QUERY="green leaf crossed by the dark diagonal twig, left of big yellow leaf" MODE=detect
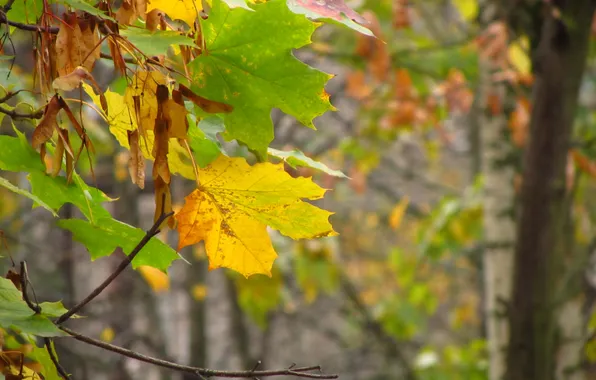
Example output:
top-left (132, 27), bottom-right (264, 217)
top-left (58, 218), bottom-right (179, 272)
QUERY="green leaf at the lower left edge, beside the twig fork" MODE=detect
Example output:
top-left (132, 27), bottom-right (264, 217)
top-left (0, 277), bottom-right (67, 337)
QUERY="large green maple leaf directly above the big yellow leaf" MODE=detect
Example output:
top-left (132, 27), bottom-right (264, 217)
top-left (190, 0), bottom-right (334, 157)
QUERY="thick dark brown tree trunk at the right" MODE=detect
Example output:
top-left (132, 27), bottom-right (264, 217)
top-left (507, 0), bottom-right (596, 380)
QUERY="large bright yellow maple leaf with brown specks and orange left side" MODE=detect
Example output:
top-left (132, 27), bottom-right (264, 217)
top-left (175, 156), bottom-right (336, 277)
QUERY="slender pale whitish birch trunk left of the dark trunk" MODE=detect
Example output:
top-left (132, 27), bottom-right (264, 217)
top-left (472, 1), bottom-right (516, 380)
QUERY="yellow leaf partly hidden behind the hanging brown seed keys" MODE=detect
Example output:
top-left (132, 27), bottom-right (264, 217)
top-left (83, 83), bottom-right (195, 180)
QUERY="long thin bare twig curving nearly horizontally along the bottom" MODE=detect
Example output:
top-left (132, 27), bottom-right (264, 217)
top-left (59, 326), bottom-right (338, 379)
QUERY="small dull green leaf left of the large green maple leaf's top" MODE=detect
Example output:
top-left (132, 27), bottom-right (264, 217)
top-left (120, 28), bottom-right (197, 56)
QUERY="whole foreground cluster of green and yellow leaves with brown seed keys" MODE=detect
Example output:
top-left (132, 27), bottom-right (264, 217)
top-left (0, 0), bottom-right (382, 379)
